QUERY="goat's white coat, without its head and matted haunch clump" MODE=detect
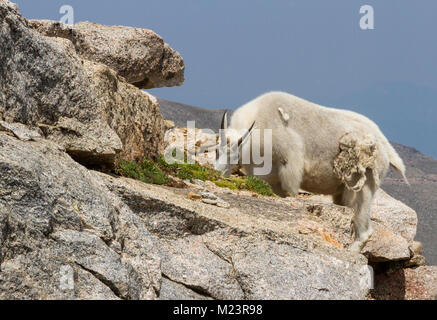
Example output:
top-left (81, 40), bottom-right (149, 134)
top-left (220, 92), bottom-right (406, 251)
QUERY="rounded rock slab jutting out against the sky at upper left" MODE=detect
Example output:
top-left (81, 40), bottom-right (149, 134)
top-left (29, 20), bottom-right (185, 89)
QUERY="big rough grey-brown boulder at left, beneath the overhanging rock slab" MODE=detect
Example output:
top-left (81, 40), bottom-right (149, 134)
top-left (0, 0), bottom-right (165, 167)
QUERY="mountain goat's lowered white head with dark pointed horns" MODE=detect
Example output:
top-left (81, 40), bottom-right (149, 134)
top-left (214, 112), bottom-right (255, 176)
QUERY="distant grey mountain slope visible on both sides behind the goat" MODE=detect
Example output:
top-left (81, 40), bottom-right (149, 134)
top-left (157, 98), bottom-right (437, 265)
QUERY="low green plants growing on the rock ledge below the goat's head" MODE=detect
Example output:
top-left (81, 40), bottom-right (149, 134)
top-left (116, 157), bottom-right (274, 196)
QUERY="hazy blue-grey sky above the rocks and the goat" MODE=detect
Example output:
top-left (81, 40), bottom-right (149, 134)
top-left (16, 0), bottom-right (437, 158)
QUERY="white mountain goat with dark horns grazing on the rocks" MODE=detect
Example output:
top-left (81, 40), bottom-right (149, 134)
top-left (214, 92), bottom-right (408, 251)
